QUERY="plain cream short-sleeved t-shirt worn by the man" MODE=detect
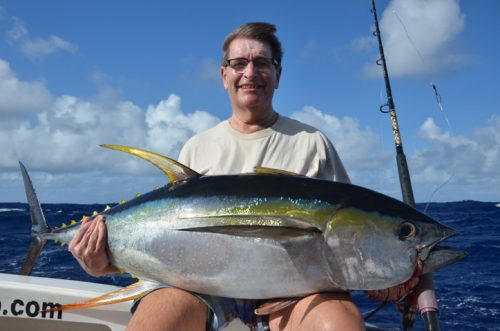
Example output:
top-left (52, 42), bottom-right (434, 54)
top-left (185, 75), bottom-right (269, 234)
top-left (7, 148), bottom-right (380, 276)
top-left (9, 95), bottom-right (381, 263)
top-left (179, 115), bottom-right (349, 183)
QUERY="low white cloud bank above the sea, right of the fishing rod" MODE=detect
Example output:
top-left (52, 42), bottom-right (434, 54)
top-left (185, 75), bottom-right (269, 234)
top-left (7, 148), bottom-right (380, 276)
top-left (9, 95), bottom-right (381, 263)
top-left (410, 116), bottom-right (500, 200)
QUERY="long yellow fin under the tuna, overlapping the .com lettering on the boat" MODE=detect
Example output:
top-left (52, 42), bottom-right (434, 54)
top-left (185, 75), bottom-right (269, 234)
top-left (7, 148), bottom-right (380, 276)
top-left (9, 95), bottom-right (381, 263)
top-left (45, 280), bottom-right (159, 312)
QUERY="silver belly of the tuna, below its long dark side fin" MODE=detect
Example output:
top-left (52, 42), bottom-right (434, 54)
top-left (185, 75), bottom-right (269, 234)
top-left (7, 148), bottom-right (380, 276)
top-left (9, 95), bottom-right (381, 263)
top-left (108, 224), bottom-right (335, 299)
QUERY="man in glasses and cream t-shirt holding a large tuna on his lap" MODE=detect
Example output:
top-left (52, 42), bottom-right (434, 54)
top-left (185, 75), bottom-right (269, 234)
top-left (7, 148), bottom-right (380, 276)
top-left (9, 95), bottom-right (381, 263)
top-left (69, 23), bottom-right (382, 331)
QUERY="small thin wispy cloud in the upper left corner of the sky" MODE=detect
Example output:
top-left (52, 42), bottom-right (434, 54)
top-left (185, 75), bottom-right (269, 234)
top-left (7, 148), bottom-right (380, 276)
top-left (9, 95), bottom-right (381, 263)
top-left (7, 18), bottom-right (78, 62)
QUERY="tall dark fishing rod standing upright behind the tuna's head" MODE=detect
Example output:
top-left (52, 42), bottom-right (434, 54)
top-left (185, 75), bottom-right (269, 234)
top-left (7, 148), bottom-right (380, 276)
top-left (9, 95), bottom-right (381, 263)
top-left (371, 0), bottom-right (440, 331)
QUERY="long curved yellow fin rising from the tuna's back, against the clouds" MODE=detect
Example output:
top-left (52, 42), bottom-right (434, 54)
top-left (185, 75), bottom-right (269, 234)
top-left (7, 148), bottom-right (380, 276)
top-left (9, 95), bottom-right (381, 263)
top-left (101, 144), bottom-right (200, 184)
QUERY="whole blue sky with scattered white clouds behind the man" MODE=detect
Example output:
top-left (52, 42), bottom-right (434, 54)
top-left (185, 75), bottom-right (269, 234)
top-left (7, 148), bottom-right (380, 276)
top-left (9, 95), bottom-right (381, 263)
top-left (0, 0), bottom-right (500, 203)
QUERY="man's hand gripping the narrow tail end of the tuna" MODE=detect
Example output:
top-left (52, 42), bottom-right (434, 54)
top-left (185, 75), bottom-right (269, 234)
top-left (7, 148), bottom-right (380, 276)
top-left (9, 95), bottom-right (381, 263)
top-left (68, 215), bottom-right (118, 277)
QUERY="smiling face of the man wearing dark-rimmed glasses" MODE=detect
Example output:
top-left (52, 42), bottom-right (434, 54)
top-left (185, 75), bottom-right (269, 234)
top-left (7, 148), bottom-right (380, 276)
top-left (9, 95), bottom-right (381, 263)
top-left (220, 38), bottom-right (281, 111)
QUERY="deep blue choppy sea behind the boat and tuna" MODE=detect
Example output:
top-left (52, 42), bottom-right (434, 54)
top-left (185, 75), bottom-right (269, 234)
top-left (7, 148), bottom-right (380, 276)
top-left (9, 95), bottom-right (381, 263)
top-left (0, 201), bottom-right (500, 331)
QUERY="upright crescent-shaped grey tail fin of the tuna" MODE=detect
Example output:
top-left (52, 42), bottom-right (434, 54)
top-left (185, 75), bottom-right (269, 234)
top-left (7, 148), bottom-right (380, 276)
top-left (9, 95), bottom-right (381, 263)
top-left (19, 162), bottom-right (50, 275)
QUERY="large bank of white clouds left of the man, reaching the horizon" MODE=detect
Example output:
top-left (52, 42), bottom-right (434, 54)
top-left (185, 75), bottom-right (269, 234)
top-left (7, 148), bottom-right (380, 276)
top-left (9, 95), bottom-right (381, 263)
top-left (0, 60), bottom-right (219, 203)
